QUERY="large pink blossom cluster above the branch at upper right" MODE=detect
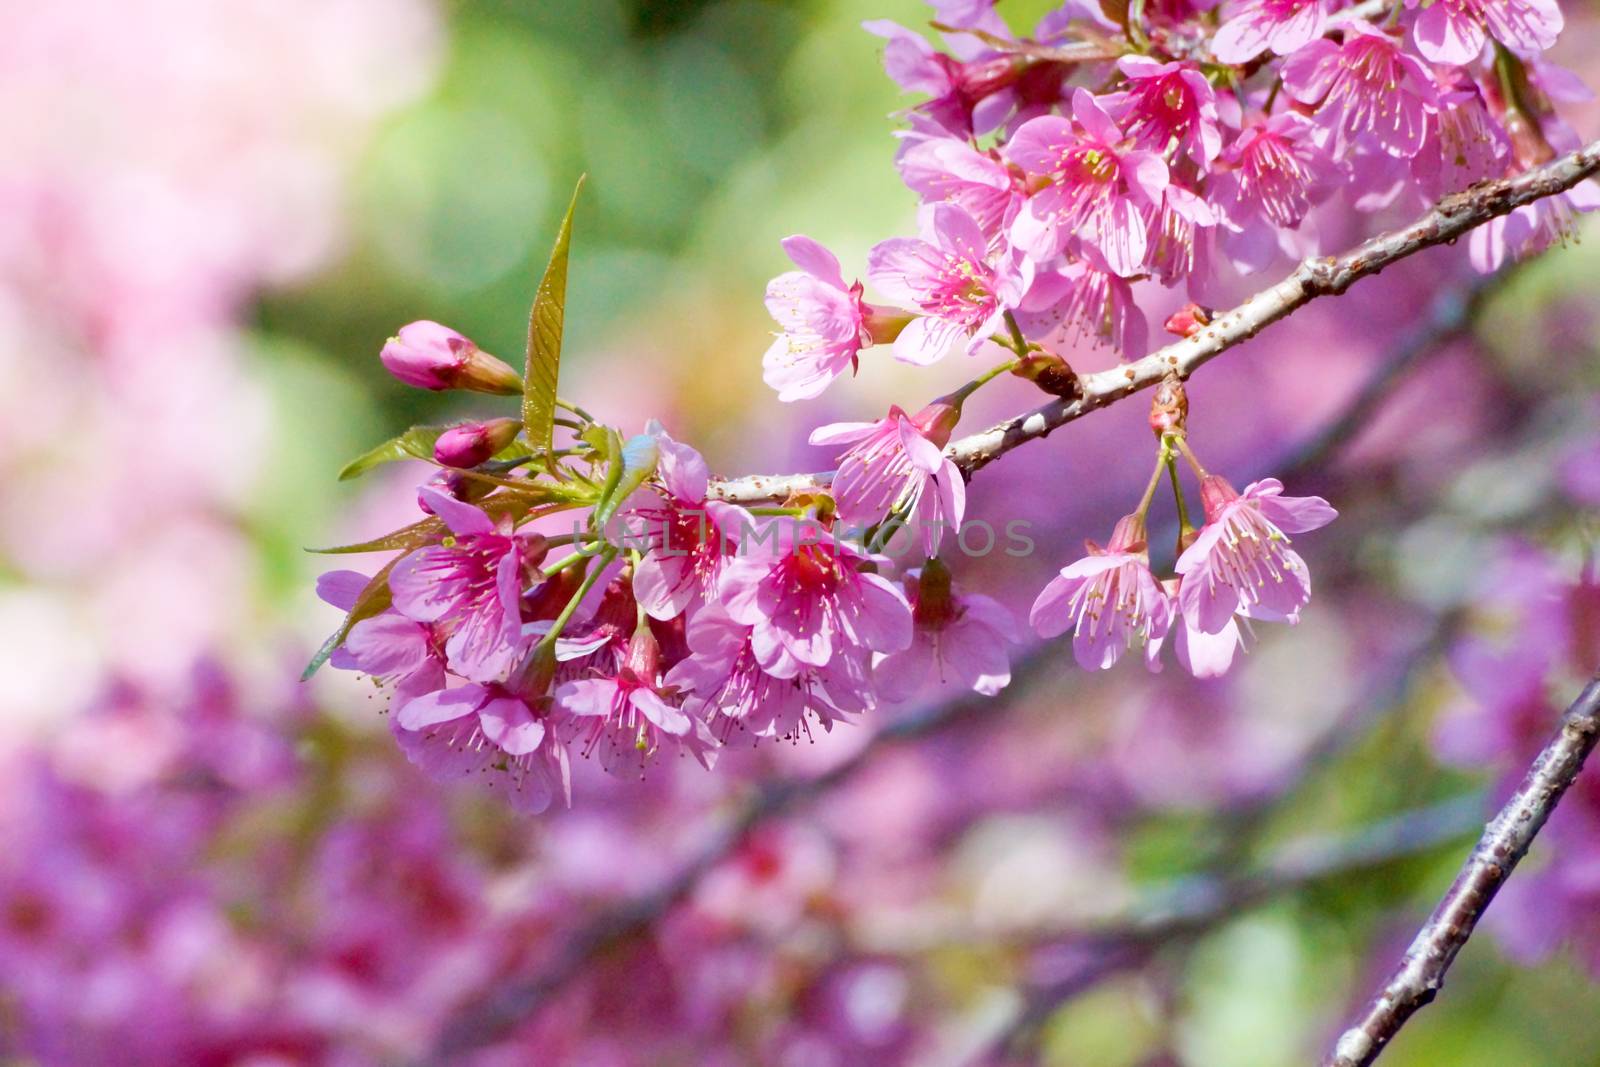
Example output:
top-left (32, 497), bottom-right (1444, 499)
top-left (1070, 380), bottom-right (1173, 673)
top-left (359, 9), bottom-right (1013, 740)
top-left (766, 0), bottom-right (1600, 400)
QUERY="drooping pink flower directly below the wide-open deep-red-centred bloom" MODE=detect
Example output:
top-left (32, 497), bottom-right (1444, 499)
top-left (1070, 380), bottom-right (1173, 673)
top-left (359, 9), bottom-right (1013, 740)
top-left (666, 601), bottom-right (872, 741)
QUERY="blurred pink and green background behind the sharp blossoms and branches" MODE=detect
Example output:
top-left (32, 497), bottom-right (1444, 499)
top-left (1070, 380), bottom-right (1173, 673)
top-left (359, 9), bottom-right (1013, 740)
top-left (0, 0), bottom-right (1600, 1067)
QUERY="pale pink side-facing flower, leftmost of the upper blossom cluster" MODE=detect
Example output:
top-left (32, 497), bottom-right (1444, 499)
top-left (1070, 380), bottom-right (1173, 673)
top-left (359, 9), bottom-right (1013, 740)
top-left (762, 234), bottom-right (872, 402)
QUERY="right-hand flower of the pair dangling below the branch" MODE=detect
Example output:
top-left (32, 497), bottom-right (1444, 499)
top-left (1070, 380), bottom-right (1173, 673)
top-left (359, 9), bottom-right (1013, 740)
top-left (1176, 475), bottom-right (1338, 633)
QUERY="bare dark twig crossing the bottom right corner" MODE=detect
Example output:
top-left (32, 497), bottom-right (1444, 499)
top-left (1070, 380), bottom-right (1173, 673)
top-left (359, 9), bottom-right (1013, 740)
top-left (1323, 675), bottom-right (1600, 1067)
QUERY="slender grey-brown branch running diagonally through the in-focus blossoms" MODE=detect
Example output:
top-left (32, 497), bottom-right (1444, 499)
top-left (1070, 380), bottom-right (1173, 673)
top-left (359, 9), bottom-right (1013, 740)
top-left (712, 141), bottom-right (1600, 504)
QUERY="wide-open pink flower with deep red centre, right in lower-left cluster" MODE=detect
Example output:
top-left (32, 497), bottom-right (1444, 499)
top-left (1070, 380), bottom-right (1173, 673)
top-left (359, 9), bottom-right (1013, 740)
top-left (717, 517), bottom-right (912, 672)
